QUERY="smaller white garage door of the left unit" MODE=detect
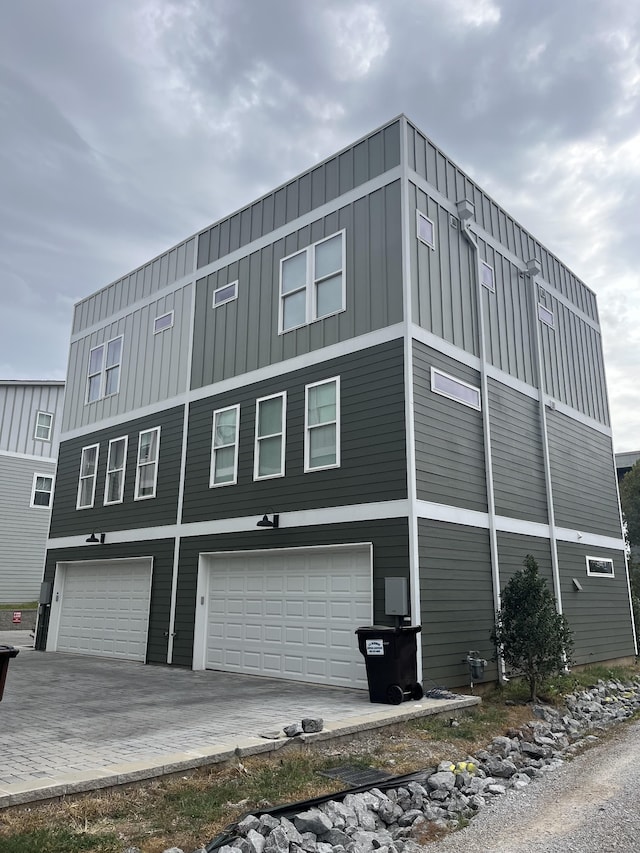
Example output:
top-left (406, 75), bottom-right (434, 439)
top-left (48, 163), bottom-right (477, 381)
top-left (51, 558), bottom-right (151, 661)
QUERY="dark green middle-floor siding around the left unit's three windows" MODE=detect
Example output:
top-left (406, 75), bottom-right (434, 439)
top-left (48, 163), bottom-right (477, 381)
top-left (50, 406), bottom-right (184, 537)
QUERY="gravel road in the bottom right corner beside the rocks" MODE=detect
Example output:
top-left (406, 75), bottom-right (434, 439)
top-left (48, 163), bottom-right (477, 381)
top-left (425, 722), bottom-right (640, 853)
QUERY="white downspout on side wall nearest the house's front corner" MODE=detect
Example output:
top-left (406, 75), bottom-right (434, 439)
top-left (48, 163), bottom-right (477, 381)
top-left (456, 198), bottom-right (509, 684)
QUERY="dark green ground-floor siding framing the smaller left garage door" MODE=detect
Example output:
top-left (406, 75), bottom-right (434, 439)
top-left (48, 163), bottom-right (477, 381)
top-left (37, 539), bottom-right (174, 663)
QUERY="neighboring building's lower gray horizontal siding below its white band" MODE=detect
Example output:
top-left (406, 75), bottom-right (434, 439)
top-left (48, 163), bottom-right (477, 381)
top-left (0, 453), bottom-right (56, 604)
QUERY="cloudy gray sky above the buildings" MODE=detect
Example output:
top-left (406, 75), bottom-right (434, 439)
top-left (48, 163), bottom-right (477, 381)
top-left (0, 0), bottom-right (640, 451)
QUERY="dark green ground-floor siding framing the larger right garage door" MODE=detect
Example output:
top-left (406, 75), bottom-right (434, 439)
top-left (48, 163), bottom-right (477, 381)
top-left (173, 518), bottom-right (409, 666)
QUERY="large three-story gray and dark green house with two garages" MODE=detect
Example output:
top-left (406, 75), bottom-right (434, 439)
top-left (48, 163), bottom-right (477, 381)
top-left (38, 116), bottom-right (636, 687)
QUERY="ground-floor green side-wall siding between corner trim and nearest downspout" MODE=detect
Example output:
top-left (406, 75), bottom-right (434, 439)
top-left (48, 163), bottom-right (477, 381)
top-left (418, 519), bottom-right (497, 687)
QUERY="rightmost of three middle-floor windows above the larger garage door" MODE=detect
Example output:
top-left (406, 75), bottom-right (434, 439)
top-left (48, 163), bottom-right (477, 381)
top-left (304, 377), bottom-right (340, 471)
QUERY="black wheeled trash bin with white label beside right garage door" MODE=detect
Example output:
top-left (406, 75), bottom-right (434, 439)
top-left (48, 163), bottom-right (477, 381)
top-left (356, 625), bottom-right (424, 705)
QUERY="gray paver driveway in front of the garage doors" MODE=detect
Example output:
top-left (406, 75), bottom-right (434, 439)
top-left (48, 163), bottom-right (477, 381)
top-left (0, 632), bottom-right (479, 808)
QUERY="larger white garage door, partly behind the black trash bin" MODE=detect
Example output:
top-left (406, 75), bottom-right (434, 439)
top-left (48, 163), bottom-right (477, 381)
top-left (201, 545), bottom-right (372, 688)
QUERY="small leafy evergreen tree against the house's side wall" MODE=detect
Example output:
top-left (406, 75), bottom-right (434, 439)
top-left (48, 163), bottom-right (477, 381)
top-left (491, 554), bottom-right (573, 702)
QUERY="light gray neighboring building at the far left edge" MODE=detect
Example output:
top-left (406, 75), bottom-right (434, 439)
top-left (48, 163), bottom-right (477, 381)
top-left (0, 379), bottom-right (64, 604)
